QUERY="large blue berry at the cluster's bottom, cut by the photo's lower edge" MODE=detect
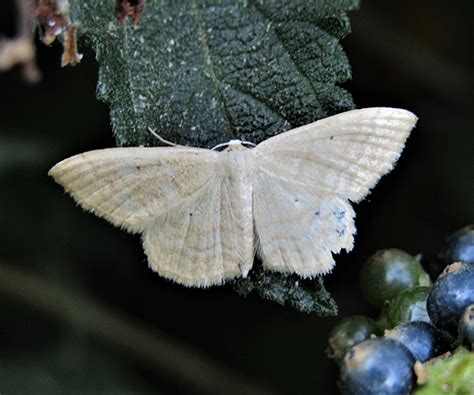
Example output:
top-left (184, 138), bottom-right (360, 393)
top-left (340, 338), bottom-right (415, 395)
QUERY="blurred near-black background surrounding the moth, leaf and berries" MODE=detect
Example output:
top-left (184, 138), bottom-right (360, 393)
top-left (0, 0), bottom-right (474, 394)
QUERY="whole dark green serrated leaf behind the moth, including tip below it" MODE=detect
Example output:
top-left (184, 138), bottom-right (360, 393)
top-left (70, 0), bottom-right (359, 315)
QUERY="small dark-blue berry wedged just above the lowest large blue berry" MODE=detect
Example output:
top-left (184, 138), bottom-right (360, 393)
top-left (385, 321), bottom-right (449, 362)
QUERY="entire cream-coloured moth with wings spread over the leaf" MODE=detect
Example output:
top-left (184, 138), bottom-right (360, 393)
top-left (49, 108), bottom-right (417, 287)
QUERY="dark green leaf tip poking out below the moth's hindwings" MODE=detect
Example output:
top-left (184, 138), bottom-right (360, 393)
top-left (232, 265), bottom-right (337, 317)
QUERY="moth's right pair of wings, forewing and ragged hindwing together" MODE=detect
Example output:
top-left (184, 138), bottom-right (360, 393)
top-left (254, 108), bottom-right (417, 276)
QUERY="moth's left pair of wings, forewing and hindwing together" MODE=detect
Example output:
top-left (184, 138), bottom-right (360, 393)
top-left (49, 147), bottom-right (254, 286)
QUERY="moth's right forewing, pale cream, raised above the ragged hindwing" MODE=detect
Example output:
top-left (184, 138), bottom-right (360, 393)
top-left (255, 107), bottom-right (417, 202)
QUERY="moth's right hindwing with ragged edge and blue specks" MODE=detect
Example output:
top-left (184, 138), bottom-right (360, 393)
top-left (254, 171), bottom-right (355, 277)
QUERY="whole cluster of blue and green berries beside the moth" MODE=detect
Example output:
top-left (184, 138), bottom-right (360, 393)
top-left (328, 226), bottom-right (474, 395)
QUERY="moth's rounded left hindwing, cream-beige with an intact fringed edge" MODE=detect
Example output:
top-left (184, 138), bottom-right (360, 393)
top-left (142, 177), bottom-right (254, 287)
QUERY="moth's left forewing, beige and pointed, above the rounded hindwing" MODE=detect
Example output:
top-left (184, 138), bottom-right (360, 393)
top-left (49, 147), bottom-right (217, 233)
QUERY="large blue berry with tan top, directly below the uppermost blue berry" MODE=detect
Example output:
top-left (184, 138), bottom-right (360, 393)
top-left (427, 262), bottom-right (474, 336)
